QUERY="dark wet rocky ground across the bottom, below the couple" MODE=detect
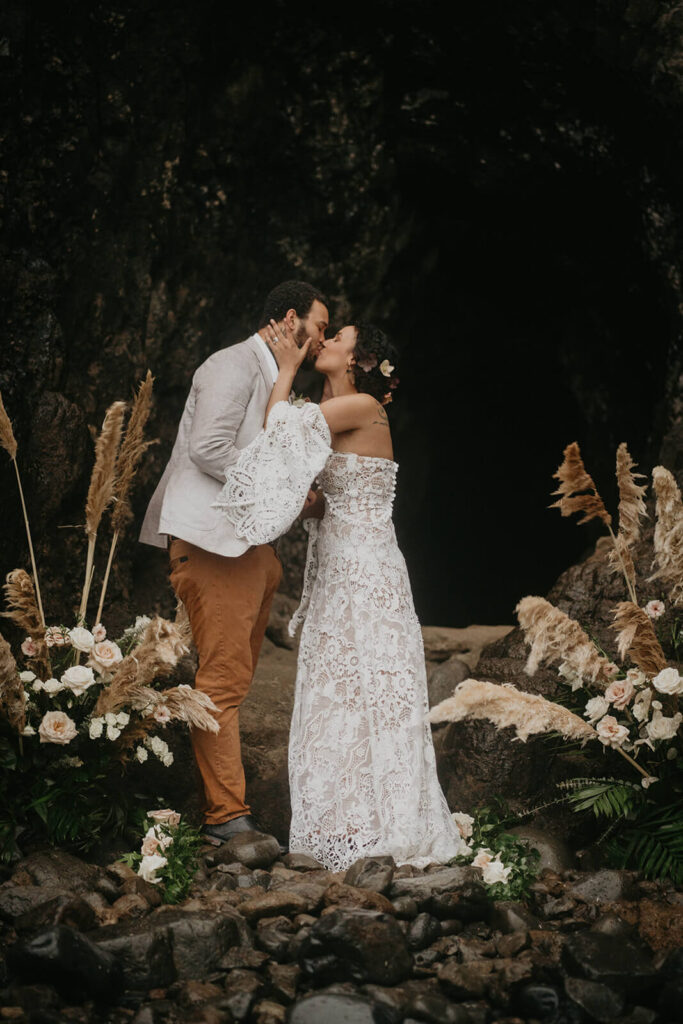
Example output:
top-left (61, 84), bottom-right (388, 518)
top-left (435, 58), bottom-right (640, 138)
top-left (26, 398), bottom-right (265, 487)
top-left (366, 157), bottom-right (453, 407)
top-left (0, 833), bottom-right (683, 1024)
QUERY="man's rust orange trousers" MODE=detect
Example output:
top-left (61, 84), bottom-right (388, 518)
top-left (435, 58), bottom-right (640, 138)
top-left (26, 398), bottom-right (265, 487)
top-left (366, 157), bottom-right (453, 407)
top-left (170, 540), bottom-right (282, 824)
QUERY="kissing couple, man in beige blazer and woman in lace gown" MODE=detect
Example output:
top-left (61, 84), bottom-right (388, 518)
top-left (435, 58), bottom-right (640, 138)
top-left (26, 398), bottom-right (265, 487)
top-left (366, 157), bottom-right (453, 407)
top-left (140, 281), bottom-right (466, 870)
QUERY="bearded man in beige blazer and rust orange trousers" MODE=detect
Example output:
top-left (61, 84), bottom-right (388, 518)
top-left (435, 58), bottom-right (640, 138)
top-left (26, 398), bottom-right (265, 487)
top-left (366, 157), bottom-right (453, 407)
top-left (140, 281), bottom-right (329, 846)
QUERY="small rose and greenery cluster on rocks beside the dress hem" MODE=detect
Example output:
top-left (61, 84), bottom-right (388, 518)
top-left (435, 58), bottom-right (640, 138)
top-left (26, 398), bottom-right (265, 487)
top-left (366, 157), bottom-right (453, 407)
top-left (453, 807), bottom-right (541, 900)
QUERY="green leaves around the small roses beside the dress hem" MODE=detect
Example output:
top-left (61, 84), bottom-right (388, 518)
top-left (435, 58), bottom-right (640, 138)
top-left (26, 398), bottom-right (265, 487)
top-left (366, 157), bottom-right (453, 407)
top-left (452, 800), bottom-right (541, 900)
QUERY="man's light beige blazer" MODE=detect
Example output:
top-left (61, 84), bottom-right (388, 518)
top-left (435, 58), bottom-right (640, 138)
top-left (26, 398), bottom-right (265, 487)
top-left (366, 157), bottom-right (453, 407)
top-left (140, 334), bottom-right (276, 556)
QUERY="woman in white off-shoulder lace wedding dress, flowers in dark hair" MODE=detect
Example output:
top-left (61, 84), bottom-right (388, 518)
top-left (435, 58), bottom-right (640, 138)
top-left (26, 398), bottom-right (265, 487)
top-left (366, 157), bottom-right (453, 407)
top-left (216, 321), bottom-right (466, 870)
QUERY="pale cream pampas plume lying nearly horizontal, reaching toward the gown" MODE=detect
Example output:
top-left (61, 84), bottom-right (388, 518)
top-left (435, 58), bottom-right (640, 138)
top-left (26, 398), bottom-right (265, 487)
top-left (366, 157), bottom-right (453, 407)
top-left (429, 679), bottom-right (597, 742)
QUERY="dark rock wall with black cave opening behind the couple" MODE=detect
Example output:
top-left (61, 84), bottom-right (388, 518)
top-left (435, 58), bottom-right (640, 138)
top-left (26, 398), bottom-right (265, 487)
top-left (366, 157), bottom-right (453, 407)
top-left (0, 0), bottom-right (683, 625)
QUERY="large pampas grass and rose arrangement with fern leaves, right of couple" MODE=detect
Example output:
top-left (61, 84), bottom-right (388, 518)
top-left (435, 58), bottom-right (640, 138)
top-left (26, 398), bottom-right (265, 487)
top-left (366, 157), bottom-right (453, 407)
top-left (430, 443), bottom-right (683, 882)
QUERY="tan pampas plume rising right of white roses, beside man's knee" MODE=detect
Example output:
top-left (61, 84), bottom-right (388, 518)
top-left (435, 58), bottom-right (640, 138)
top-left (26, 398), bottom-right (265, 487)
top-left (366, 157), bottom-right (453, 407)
top-left (94, 617), bottom-right (187, 715)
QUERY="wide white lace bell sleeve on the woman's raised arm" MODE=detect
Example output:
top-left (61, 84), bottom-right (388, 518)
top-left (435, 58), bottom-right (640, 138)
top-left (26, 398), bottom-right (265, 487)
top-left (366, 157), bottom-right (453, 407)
top-left (211, 401), bottom-right (332, 544)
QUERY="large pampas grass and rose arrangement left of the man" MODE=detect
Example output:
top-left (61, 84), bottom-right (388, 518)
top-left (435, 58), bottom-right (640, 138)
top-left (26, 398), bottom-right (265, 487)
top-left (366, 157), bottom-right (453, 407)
top-left (0, 374), bottom-right (218, 858)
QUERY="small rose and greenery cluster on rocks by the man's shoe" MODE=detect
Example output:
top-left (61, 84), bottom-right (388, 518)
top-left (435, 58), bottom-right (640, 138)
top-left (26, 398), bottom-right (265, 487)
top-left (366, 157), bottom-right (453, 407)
top-left (122, 807), bottom-right (202, 903)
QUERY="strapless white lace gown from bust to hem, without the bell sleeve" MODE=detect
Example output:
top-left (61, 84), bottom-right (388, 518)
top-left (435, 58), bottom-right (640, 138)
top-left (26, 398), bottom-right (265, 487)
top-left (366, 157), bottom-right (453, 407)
top-left (289, 453), bottom-right (465, 870)
